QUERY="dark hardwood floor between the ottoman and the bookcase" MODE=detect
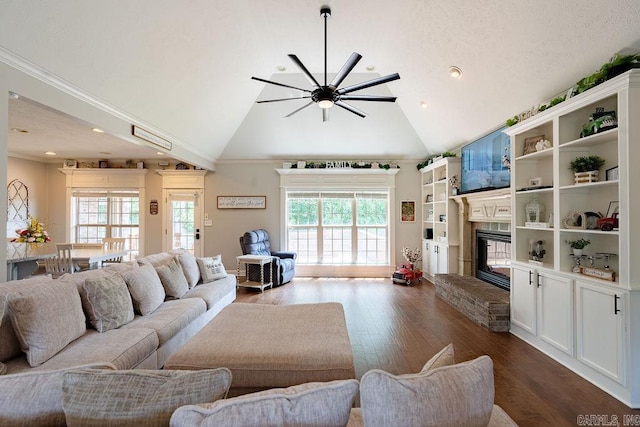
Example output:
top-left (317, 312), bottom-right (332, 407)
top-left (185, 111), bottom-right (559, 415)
top-left (237, 278), bottom-right (640, 426)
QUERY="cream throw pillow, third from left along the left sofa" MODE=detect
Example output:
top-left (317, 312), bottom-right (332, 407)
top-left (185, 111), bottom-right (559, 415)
top-left (122, 265), bottom-right (165, 316)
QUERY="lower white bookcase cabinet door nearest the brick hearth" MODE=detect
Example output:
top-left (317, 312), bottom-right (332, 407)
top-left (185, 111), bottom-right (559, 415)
top-left (511, 265), bottom-right (537, 335)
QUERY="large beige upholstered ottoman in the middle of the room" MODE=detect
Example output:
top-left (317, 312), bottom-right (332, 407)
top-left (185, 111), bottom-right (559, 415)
top-left (164, 303), bottom-right (355, 396)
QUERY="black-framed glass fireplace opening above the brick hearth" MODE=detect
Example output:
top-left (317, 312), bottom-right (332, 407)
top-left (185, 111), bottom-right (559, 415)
top-left (475, 230), bottom-right (511, 290)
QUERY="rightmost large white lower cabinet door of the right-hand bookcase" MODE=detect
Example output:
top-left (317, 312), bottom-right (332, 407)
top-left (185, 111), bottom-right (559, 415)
top-left (576, 281), bottom-right (626, 385)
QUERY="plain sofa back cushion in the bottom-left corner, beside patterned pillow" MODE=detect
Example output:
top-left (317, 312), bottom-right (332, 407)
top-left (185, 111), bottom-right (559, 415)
top-left (0, 363), bottom-right (116, 426)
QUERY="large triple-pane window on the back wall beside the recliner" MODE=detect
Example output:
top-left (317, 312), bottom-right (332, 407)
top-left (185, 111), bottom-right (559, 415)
top-left (287, 191), bottom-right (389, 265)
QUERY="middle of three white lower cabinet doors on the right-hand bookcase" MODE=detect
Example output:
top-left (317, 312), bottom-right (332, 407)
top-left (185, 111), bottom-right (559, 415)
top-left (537, 270), bottom-right (574, 356)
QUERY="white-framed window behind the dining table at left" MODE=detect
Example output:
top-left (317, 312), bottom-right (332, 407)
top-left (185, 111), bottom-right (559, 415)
top-left (71, 191), bottom-right (140, 258)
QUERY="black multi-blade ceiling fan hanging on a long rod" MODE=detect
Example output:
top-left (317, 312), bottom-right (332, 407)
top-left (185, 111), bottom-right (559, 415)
top-left (251, 6), bottom-right (400, 122)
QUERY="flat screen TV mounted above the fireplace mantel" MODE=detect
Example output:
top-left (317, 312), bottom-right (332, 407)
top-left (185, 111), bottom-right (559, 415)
top-left (460, 127), bottom-right (511, 193)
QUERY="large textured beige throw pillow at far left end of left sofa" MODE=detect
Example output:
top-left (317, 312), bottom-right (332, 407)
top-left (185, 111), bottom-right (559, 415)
top-left (7, 282), bottom-right (87, 367)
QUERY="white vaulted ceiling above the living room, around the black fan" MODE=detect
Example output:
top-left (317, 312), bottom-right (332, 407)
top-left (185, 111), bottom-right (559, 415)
top-left (0, 0), bottom-right (640, 166)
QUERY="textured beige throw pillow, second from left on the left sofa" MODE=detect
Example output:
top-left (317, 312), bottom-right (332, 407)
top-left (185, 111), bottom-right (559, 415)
top-left (80, 274), bottom-right (134, 332)
